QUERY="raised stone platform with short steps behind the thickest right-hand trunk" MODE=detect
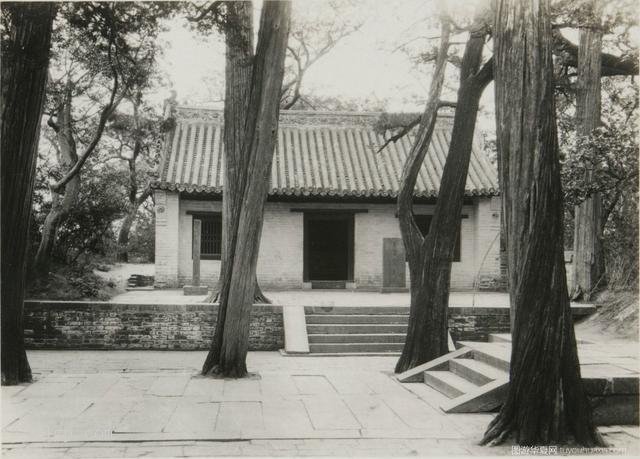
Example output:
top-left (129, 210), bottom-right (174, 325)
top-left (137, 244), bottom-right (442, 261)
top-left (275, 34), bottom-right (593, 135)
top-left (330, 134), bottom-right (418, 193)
top-left (397, 335), bottom-right (640, 425)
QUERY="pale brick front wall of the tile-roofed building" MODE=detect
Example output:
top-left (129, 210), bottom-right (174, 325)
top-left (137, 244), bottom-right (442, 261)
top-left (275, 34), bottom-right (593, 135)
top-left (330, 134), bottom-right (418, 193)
top-left (156, 192), bottom-right (500, 290)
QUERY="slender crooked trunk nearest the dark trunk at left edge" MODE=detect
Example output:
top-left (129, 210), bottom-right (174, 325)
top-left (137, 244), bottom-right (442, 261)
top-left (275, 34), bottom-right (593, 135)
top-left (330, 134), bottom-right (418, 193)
top-left (34, 82), bottom-right (80, 276)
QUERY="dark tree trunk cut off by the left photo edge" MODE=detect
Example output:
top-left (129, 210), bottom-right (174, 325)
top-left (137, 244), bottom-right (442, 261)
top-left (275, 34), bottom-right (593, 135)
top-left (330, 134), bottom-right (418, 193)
top-left (0, 3), bottom-right (56, 385)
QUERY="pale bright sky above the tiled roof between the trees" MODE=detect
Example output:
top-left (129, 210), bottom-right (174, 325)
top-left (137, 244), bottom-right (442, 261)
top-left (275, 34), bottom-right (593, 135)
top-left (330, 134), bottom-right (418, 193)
top-left (158, 0), bottom-right (492, 115)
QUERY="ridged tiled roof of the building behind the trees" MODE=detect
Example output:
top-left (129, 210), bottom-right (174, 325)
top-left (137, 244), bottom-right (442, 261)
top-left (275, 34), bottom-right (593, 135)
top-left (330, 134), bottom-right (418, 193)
top-left (153, 107), bottom-right (498, 198)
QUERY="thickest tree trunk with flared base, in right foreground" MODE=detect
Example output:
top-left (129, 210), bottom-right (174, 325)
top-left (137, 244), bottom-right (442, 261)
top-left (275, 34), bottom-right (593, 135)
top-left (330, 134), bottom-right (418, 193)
top-left (482, 0), bottom-right (602, 446)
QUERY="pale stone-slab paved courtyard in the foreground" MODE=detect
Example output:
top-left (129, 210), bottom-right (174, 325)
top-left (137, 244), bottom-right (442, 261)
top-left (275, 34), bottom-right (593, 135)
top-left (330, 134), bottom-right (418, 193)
top-left (2, 351), bottom-right (640, 458)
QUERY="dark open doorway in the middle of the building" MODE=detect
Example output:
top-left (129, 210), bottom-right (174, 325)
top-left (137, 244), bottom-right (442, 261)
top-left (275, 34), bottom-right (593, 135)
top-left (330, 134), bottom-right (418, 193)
top-left (304, 213), bottom-right (353, 282)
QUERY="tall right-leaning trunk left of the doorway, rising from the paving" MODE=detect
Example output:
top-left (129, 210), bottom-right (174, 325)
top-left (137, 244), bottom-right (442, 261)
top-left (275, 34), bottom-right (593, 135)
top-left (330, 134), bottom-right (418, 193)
top-left (203, 1), bottom-right (291, 377)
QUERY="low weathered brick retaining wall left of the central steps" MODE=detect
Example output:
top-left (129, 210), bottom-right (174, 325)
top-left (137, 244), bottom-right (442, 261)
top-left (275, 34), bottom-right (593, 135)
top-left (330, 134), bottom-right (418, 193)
top-left (24, 300), bottom-right (284, 351)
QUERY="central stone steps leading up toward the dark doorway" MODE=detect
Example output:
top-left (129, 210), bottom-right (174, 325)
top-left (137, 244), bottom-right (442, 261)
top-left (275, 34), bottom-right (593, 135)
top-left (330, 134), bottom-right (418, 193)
top-left (305, 306), bottom-right (409, 355)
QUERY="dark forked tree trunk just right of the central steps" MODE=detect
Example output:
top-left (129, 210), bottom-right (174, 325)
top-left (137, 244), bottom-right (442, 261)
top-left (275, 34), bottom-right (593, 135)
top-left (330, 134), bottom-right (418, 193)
top-left (395, 20), bottom-right (491, 373)
